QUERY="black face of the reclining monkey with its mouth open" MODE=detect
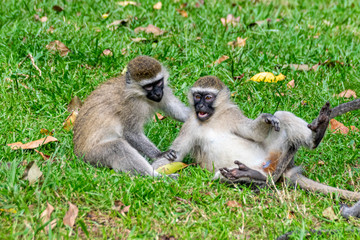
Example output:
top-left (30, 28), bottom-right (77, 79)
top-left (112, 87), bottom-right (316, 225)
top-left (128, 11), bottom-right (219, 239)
top-left (193, 92), bottom-right (216, 121)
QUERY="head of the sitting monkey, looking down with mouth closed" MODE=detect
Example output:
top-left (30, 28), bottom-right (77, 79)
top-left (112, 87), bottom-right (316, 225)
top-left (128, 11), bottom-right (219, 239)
top-left (126, 56), bottom-right (169, 102)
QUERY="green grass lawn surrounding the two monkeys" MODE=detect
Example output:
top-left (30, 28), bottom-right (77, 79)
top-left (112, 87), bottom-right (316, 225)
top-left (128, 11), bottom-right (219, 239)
top-left (0, 0), bottom-right (360, 239)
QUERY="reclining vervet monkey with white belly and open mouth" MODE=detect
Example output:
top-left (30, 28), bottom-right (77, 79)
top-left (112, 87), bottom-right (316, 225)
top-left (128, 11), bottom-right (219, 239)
top-left (162, 76), bottom-right (360, 218)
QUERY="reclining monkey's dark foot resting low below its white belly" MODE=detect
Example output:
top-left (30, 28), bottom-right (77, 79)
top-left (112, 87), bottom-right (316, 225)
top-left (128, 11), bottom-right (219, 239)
top-left (219, 161), bottom-right (266, 181)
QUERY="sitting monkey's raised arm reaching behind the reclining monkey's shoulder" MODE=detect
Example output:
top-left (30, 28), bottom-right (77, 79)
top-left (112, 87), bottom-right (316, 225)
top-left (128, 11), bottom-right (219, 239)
top-left (160, 87), bottom-right (190, 122)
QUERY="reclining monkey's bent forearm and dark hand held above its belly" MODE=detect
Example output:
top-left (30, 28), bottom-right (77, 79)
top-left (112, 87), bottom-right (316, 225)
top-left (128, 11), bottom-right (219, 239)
top-left (234, 113), bottom-right (280, 142)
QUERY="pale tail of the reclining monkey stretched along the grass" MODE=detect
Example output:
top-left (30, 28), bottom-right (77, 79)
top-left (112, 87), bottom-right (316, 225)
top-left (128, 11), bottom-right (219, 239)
top-left (285, 167), bottom-right (360, 200)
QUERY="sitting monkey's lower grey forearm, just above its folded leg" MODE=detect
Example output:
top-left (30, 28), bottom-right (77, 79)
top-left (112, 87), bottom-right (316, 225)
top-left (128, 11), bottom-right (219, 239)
top-left (124, 131), bottom-right (161, 159)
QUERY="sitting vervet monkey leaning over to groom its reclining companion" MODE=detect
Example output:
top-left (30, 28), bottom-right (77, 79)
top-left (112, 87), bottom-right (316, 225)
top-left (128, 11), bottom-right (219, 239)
top-left (74, 56), bottom-right (190, 176)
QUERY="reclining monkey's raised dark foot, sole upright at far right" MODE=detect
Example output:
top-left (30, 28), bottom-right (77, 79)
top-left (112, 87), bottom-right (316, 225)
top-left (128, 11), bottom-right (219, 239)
top-left (308, 101), bottom-right (331, 148)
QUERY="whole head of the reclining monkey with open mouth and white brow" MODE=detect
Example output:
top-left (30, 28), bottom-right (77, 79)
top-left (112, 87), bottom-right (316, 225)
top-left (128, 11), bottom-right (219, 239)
top-left (188, 76), bottom-right (230, 121)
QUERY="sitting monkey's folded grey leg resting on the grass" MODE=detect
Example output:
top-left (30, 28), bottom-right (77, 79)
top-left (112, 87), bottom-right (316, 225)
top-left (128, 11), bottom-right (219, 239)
top-left (85, 139), bottom-right (159, 176)
